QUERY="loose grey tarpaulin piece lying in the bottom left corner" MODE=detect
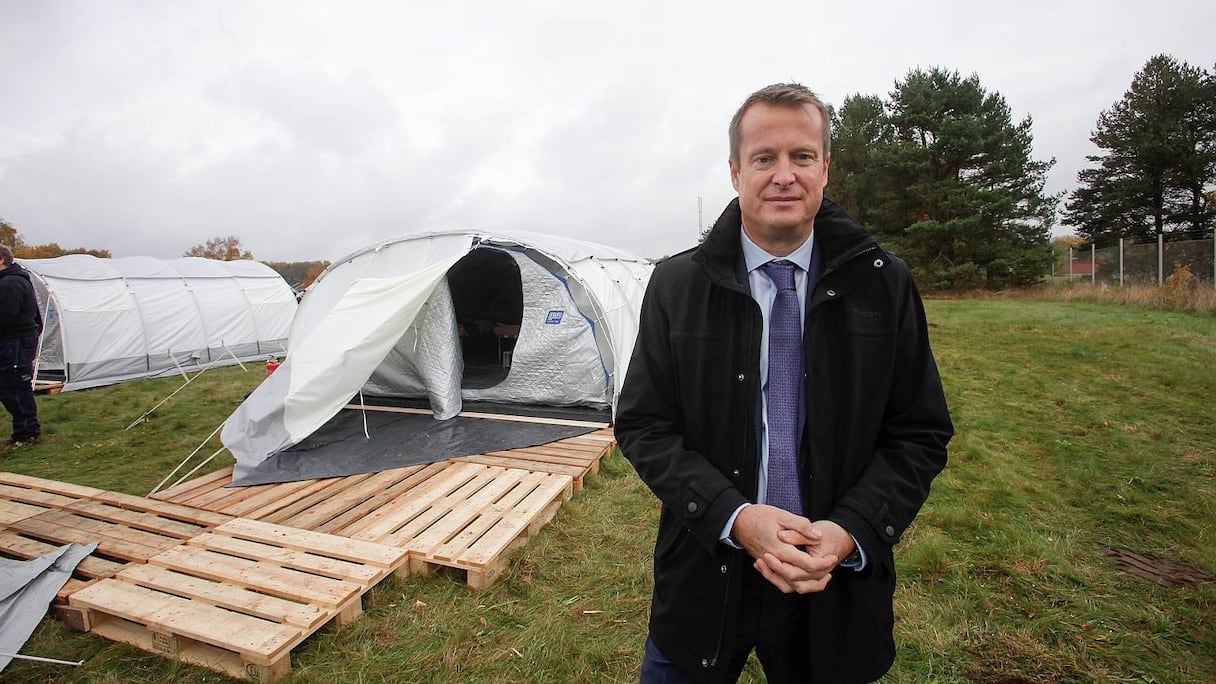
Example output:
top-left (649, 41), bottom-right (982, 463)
top-left (0, 542), bottom-right (97, 671)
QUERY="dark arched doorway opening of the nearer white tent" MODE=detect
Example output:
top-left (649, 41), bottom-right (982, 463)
top-left (447, 247), bottom-right (524, 389)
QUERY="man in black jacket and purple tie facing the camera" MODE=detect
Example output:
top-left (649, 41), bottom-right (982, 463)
top-left (615, 84), bottom-right (953, 684)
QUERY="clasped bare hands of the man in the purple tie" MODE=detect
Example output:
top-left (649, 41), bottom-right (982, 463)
top-left (731, 504), bottom-right (856, 594)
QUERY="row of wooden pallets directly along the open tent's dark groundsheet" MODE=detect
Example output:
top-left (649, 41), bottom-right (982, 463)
top-left (153, 428), bottom-right (615, 588)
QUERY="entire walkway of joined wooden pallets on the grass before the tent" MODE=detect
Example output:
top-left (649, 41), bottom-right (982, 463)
top-left (0, 430), bottom-right (615, 682)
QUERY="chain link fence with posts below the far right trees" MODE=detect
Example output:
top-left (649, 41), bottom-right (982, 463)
top-left (1052, 237), bottom-right (1216, 287)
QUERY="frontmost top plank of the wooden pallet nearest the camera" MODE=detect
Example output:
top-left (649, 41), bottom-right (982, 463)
top-left (69, 578), bottom-right (304, 663)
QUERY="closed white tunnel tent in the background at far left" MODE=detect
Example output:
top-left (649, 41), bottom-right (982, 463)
top-left (17, 254), bottom-right (297, 389)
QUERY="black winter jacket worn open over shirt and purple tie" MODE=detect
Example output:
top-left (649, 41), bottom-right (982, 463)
top-left (615, 200), bottom-right (953, 684)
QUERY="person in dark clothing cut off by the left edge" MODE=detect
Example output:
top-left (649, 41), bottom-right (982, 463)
top-left (0, 245), bottom-right (43, 445)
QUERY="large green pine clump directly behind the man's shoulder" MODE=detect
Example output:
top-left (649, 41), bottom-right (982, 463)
top-left (829, 68), bottom-right (1059, 288)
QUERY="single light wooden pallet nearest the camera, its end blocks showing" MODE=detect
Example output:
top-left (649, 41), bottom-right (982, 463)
top-left (68, 518), bottom-right (409, 682)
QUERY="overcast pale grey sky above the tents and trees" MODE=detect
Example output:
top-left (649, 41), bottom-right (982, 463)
top-left (0, 0), bottom-right (1216, 260)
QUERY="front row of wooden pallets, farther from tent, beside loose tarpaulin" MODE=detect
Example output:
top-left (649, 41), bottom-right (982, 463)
top-left (0, 473), bottom-right (409, 682)
